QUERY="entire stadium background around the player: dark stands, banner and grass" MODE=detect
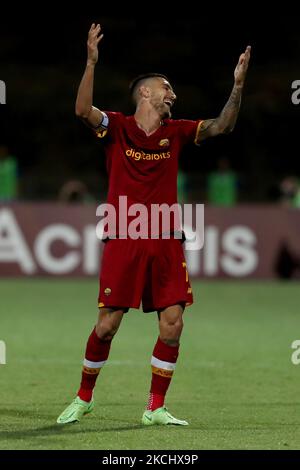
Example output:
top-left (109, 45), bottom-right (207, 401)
top-left (0, 13), bottom-right (300, 449)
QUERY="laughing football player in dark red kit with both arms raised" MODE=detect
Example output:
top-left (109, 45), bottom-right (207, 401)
top-left (57, 24), bottom-right (250, 425)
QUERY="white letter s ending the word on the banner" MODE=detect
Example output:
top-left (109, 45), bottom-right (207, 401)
top-left (220, 225), bottom-right (258, 277)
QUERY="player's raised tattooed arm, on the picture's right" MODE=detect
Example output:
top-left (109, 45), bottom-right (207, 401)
top-left (196, 46), bottom-right (251, 144)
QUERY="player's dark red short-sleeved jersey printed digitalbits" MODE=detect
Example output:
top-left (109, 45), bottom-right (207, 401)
top-left (96, 112), bottom-right (201, 237)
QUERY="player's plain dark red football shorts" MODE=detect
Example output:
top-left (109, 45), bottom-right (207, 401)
top-left (98, 238), bottom-right (193, 312)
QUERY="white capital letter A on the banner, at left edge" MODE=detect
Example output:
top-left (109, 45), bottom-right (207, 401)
top-left (0, 208), bottom-right (36, 274)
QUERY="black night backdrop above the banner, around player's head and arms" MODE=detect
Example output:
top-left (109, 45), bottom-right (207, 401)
top-left (0, 13), bottom-right (300, 202)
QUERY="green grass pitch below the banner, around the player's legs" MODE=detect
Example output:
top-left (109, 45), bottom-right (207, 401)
top-left (0, 279), bottom-right (300, 450)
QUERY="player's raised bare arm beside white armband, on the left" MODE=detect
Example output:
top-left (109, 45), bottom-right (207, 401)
top-left (75, 23), bottom-right (103, 127)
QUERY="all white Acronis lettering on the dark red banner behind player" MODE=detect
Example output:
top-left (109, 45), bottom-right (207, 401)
top-left (0, 206), bottom-right (258, 278)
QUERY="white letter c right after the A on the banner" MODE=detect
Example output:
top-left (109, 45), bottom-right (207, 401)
top-left (34, 224), bottom-right (81, 274)
